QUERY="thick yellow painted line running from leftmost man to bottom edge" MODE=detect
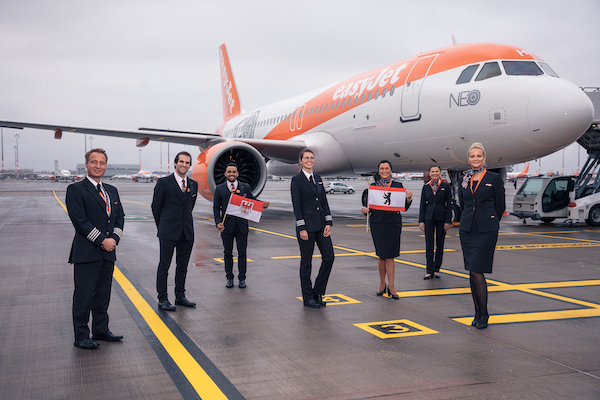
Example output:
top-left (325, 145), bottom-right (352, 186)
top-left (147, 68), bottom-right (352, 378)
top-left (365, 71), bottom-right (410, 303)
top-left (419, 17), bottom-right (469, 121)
top-left (113, 265), bottom-right (227, 399)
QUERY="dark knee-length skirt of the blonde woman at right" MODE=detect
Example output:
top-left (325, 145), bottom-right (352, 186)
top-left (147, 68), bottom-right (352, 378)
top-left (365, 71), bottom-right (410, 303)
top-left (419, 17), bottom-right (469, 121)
top-left (460, 223), bottom-right (498, 274)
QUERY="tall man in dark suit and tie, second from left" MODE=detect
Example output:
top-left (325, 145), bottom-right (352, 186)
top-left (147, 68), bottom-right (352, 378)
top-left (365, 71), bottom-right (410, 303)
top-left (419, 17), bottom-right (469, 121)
top-left (152, 151), bottom-right (198, 311)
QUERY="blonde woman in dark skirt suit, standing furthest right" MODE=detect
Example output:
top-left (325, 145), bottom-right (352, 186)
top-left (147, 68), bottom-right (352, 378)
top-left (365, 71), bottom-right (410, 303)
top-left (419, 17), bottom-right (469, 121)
top-left (459, 143), bottom-right (505, 329)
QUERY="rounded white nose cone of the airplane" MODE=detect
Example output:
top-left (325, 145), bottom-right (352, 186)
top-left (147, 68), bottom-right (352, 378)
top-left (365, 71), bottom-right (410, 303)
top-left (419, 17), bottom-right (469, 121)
top-left (528, 78), bottom-right (594, 147)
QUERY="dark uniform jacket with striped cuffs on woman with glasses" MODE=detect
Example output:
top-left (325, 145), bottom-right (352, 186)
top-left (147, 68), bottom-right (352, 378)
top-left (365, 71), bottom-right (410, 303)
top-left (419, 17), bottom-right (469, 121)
top-left (290, 171), bottom-right (333, 233)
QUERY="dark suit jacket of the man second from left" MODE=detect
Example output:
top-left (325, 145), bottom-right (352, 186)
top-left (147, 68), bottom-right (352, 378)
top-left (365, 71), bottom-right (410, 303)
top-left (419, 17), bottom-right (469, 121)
top-left (152, 173), bottom-right (198, 242)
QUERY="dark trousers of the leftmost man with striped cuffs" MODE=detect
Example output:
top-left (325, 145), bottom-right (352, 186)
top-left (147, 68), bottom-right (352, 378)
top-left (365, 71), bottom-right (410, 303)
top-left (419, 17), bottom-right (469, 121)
top-left (73, 260), bottom-right (115, 341)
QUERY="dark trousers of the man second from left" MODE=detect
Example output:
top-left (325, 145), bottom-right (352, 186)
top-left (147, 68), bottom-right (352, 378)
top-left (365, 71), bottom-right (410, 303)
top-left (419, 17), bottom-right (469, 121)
top-left (156, 233), bottom-right (194, 302)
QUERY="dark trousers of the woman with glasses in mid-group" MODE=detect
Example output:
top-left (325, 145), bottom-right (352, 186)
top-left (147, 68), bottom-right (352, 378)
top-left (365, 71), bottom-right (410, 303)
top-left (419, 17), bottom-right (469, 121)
top-left (297, 230), bottom-right (334, 300)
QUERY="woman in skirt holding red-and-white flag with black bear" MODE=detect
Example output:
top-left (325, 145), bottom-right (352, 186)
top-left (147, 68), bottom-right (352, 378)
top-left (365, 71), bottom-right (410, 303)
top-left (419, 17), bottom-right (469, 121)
top-left (361, 160), bottom-right (412, 300)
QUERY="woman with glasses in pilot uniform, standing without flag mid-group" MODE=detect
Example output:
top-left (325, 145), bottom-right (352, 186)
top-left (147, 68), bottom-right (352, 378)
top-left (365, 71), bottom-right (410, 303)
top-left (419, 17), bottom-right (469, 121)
top-left (291, 149), bottom-right (334, 308)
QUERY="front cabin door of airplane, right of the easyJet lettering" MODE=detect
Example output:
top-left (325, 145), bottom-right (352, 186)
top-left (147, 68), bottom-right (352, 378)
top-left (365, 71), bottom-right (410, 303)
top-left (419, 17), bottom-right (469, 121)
top-left (400, 54), bottom-right (439, 122)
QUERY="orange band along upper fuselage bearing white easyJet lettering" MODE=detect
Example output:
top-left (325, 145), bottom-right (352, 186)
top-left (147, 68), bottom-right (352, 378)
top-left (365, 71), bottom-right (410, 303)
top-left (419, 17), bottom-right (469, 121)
top-left (262, 43), bottom-right (541, 140)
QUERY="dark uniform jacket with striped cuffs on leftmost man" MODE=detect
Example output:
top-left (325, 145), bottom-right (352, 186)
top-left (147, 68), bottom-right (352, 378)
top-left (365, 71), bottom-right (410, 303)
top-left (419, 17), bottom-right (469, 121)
top-left (66, 178), bottom-right (125, 263)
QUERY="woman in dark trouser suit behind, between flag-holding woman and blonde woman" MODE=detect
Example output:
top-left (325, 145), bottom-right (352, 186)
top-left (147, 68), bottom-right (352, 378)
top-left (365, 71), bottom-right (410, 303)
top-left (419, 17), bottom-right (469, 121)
top-left (419, 165), bottom-right (452, 279)
